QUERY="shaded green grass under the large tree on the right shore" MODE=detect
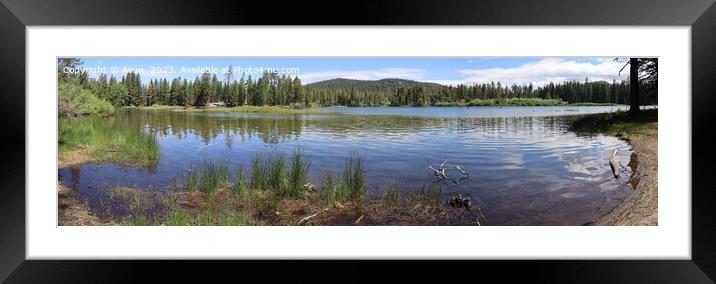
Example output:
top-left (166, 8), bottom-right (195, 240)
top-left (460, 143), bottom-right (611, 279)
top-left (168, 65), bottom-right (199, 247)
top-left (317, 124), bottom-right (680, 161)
top-left (570, 109), bottom-right (659, 138)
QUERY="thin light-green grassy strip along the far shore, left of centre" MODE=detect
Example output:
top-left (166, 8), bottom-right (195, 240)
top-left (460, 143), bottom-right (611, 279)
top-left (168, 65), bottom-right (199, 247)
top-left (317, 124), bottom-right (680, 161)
top-left (131, 105), bottom-right (334, 114)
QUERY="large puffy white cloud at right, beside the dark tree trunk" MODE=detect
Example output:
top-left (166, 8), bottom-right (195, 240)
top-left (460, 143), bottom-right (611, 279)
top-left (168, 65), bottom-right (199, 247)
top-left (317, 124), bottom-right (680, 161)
top-left (450, 58), bottom-right (628, 86)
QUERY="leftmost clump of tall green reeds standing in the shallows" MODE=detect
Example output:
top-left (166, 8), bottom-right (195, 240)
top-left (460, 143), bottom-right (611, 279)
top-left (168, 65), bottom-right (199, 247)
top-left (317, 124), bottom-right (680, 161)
top-left (184, 159), bottom-right (229, 196)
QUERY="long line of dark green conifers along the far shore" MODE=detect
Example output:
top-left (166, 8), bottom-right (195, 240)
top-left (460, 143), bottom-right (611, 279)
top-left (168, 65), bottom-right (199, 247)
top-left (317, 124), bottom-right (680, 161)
top-left (58, 58), bottom-right (656, 115)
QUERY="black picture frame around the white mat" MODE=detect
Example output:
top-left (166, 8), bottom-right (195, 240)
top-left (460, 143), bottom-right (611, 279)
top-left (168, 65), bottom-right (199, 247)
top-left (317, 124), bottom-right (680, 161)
top-left (0, 0), bottom-right (716, 283)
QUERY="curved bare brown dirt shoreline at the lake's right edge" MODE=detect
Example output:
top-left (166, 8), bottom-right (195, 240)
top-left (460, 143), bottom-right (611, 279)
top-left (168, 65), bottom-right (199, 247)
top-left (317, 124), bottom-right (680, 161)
top-left (590, 123), bottom-right (659, 226)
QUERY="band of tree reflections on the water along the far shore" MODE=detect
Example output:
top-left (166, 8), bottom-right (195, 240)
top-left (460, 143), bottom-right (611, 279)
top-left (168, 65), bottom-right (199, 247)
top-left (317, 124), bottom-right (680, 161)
top-left (115, 110), bottom-right (567, 145)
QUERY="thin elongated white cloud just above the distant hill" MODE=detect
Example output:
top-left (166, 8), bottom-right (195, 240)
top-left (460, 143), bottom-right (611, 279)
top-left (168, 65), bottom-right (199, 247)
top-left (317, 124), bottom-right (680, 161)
top-left (298, 68), bottom-right (428, 83)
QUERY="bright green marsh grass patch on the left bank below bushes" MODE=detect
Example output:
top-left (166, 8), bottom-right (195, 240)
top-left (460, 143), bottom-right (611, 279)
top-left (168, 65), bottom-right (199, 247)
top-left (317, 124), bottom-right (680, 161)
top-left (57, 117), bottom-right (159, 167)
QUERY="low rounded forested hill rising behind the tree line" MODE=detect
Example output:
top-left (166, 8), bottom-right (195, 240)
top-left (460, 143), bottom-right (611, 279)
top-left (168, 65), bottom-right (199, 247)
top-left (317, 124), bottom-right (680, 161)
top-left (306, 78), bottom-right (444, 93)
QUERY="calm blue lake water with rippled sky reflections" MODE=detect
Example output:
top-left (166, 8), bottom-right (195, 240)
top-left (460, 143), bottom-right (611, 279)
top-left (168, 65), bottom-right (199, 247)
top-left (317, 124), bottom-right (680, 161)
top-left (59, 107), bottom-right (631, 225)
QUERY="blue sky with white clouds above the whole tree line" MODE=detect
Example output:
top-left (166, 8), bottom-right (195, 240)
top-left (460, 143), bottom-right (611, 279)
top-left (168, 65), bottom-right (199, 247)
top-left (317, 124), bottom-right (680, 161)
top-left (75, 57), bottom-right (628, 86)
